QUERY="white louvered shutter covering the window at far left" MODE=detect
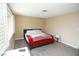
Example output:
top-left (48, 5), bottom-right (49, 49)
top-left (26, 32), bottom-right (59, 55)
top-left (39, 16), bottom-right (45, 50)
top-left (0, 3), bottom-right (9, 55)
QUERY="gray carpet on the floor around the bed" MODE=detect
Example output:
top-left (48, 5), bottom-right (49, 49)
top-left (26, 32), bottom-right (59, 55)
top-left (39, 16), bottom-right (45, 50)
top-left (15, 40), bottom-right (79, 56)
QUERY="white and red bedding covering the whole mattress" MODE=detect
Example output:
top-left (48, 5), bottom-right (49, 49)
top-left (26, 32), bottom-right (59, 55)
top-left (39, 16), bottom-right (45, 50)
top-left (25, 30), bottom-right (54, 49)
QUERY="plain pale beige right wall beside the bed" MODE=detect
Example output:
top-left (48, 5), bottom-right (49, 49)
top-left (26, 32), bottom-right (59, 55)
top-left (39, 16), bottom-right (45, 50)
top-left (45, 12), bottom-right (79, 48)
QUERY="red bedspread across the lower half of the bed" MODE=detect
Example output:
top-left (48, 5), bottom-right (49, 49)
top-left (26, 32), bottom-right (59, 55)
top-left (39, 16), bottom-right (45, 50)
top-left (27, 34), bottom-right (54, 46)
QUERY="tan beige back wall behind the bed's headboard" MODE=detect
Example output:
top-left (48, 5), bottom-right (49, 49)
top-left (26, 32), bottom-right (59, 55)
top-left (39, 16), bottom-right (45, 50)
top-left (15, 16), bottom-right (45, 38)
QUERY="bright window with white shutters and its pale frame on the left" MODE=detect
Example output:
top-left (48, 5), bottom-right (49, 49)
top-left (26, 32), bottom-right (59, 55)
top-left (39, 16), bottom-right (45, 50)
top-left (0, 3), bottom-right (14, 55)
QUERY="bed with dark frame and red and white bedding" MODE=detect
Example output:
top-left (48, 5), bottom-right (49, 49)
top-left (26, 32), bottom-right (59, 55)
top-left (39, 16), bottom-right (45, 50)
top-left (24, 29), bottom-right (54, 50)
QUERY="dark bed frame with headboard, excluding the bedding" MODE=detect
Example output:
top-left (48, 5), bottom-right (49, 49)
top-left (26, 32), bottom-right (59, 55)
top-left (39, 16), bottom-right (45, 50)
top-left (23, 29), bottom-right (53, 50)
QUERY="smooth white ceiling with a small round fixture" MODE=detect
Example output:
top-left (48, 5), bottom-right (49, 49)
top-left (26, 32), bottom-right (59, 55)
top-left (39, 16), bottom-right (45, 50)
top-left (9, 3), bottom-right (79, 18)
